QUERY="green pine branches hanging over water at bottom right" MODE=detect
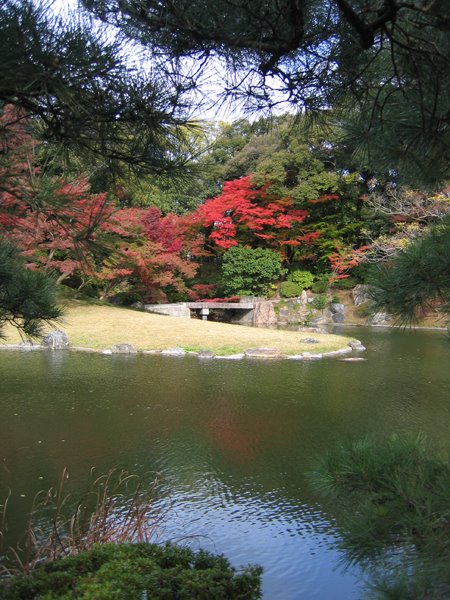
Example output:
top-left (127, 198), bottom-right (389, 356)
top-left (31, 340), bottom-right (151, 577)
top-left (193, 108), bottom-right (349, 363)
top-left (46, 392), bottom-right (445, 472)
top-left (313, 435), bottom-right (450, 600)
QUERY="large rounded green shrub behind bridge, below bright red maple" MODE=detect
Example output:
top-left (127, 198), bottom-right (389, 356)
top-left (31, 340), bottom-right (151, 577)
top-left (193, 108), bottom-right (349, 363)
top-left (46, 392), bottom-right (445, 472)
top-left (222, 246), bottom-right (283, 296)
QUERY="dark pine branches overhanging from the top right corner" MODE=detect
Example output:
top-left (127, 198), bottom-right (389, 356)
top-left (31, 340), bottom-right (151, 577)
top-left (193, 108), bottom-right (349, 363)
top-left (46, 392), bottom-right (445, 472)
top-left (82, 0), bottom-right (450, 182)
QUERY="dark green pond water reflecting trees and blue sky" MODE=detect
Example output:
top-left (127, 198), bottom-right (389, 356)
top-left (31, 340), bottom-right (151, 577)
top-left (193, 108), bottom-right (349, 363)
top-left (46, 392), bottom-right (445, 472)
top-left (0, 329), bottom-right (450, 600)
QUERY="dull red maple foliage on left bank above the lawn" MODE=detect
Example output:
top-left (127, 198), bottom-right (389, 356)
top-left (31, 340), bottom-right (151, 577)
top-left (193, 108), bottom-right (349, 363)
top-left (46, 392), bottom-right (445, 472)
top-left (0, 107), bottom-right (198, 299)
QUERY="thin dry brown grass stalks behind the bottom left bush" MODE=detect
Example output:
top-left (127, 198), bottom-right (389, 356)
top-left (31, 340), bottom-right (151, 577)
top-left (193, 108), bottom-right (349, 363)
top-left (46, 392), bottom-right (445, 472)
top-left (0, 469), bottom-right (161, 577)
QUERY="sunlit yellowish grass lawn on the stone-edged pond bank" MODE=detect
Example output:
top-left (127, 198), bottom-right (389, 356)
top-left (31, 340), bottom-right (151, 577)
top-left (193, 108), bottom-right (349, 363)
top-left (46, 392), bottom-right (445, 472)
top-left (4, 300), bottom-right (356, 354)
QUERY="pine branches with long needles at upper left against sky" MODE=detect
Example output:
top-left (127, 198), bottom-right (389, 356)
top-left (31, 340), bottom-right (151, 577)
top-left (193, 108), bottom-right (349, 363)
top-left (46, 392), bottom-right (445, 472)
top-left (0, 0), bottom-right (196, 180)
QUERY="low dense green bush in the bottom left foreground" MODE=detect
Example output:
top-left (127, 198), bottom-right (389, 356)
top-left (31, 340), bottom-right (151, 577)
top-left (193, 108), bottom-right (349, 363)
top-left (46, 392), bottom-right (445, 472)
top-left (0, 543), bottom-right (262, 600)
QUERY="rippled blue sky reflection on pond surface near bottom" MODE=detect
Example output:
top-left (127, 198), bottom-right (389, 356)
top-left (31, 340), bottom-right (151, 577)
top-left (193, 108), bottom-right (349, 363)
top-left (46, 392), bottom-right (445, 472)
top-left (151, 473), bottom-right (357, 600)
